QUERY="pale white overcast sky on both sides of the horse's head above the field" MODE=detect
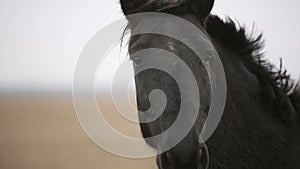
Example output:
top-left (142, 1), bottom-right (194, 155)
top-left (0, 0), bottom-right (300, 90)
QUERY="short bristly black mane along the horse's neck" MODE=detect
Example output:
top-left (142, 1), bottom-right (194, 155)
top-left (205, 15), bottom-right (300, 124)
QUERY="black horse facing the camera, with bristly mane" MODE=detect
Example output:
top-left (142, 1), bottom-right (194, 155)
top-left (121, 0), bottom-right (300, 169)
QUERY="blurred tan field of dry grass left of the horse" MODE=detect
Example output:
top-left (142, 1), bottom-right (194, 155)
top-left (0, 94), bottom-right (156, 169)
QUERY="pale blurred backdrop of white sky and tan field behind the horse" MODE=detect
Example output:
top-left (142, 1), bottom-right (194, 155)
top-left (0, 0), bottom-right (300, 169)
